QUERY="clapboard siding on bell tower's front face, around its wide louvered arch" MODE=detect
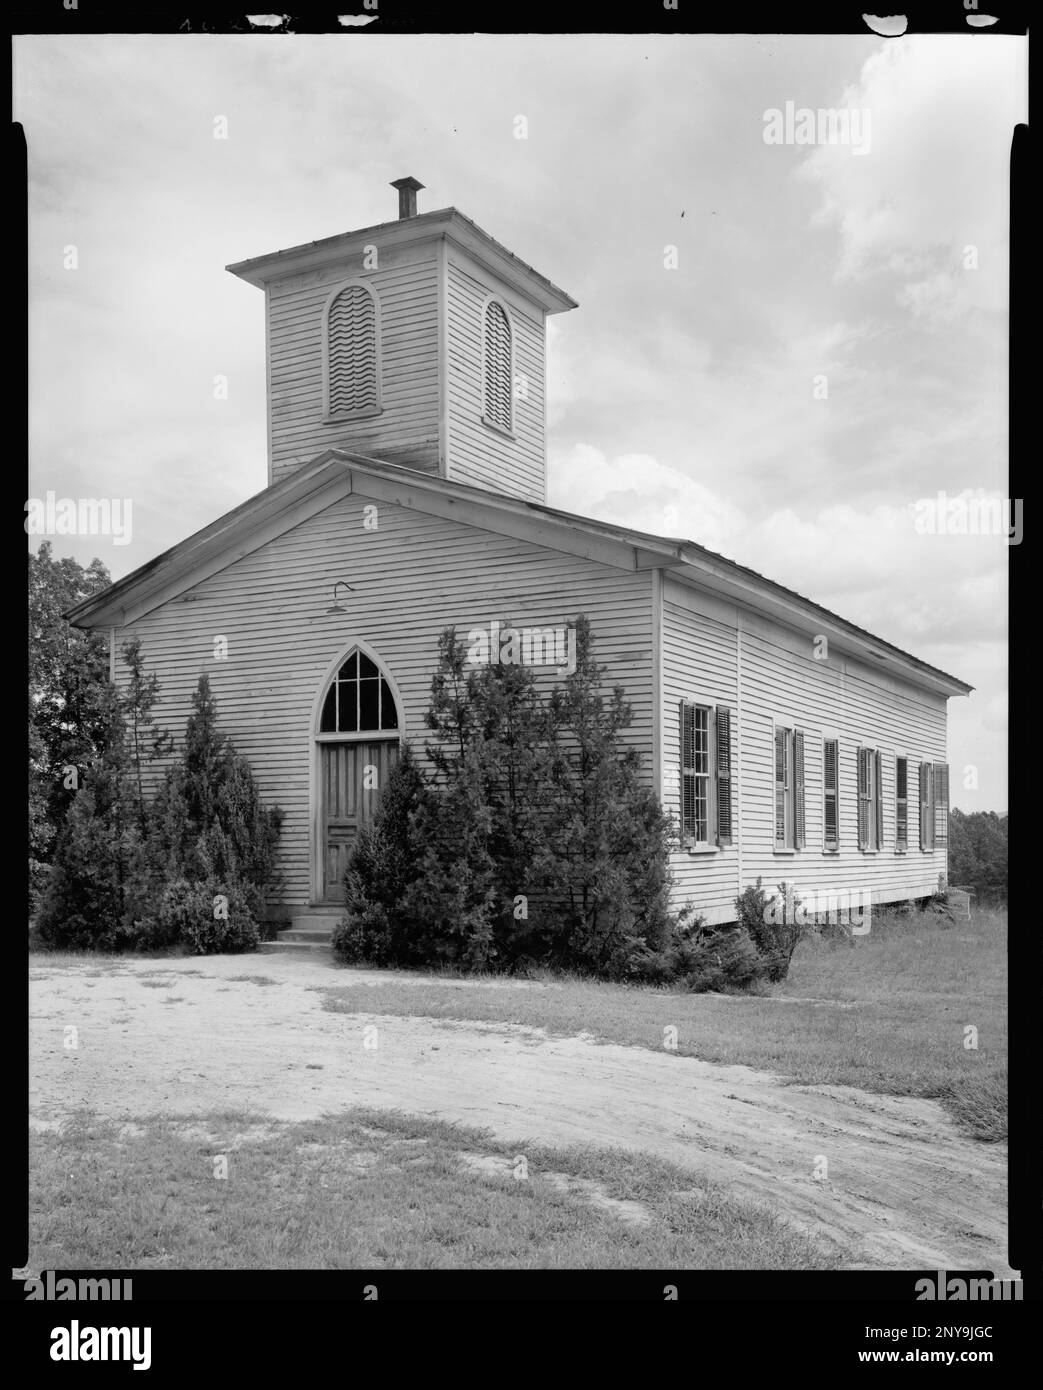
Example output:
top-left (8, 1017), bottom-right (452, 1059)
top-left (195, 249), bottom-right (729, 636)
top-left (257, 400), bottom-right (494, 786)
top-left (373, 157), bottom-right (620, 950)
top-left (268, 243), bottom-right (438, 482)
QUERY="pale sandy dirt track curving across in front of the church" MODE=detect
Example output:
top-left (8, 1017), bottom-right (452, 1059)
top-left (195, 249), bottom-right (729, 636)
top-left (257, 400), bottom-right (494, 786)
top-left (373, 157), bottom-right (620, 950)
top-left (29, 955), bottom-right (1010, 1277)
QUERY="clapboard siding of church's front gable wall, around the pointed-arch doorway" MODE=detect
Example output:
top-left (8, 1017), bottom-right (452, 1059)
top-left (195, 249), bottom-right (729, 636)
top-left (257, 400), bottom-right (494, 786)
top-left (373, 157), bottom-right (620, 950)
top-left (117, 492), bottom-right (654, 908)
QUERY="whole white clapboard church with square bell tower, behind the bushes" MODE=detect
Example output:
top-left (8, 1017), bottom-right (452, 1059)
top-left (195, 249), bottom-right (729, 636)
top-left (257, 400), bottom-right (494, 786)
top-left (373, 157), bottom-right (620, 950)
top-left (71, 178), bottom-right (971, 931)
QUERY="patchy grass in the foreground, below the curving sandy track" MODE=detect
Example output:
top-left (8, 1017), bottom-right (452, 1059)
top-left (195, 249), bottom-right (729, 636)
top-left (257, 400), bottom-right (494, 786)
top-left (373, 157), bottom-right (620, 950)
top-left (29, 1111), bottom-right (836, 1270)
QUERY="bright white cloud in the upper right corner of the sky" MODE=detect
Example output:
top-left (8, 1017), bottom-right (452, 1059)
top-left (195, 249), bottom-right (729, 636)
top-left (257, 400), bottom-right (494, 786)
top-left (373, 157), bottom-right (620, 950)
top-left (800, 35), bottom-right (1026, 320)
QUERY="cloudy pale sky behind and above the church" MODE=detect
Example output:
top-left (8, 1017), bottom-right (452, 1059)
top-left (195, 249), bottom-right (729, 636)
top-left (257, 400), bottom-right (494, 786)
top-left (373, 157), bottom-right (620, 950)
top-left (14, 31), bottom-right (1026, 810)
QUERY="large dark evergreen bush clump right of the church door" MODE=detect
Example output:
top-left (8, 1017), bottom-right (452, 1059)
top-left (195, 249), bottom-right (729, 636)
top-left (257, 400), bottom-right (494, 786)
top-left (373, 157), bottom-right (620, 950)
top-left (334, 617), bottom-right (717, 980)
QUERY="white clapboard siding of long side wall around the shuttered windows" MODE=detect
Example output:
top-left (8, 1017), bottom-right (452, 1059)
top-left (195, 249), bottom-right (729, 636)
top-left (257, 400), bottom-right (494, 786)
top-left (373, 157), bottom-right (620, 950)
top-left (661, 578), bottom-right (946, 922)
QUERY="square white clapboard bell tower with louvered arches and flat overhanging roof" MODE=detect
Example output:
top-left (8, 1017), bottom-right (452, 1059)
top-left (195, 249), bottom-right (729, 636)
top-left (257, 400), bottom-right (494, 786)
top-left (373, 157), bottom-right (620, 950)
top-left (228, 177), bottom-right (576, 502)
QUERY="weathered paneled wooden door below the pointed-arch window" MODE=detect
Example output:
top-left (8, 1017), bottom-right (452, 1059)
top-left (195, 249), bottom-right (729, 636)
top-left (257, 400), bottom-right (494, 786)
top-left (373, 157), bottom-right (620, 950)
top-left (320, 738), bottom-right (399, 902)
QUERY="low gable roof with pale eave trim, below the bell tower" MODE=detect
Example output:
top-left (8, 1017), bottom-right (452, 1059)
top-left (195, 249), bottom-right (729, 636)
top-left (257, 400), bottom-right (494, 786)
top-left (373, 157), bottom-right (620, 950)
top-left (65, 449), bottom-right (973, 695)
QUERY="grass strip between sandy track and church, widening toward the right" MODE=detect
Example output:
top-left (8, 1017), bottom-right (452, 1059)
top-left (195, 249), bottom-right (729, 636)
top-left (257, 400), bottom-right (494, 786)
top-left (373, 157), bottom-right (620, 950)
top-left (324, 909), bottom-right (1007, 1141)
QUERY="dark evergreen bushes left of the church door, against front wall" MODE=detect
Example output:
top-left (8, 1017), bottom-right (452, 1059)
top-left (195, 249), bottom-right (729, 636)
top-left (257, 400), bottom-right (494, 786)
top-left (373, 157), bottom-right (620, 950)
top-left (35, 664), bottom-right (282, 955)
